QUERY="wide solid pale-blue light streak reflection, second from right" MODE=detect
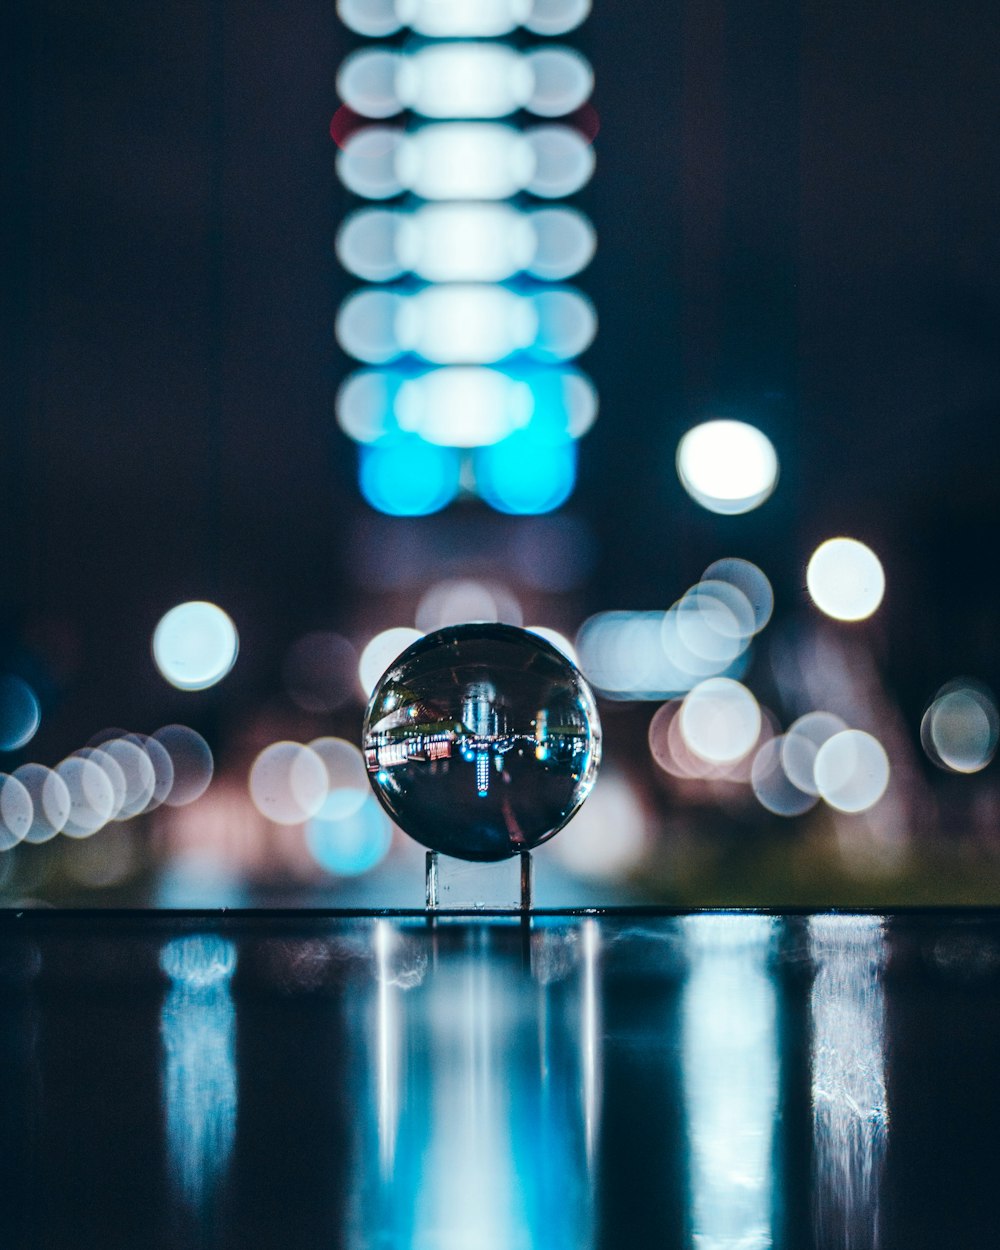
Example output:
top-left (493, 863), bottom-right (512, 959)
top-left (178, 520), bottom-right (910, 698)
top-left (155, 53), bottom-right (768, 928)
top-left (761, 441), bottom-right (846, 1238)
top-left (681, 915), bottom-right (779, 1250)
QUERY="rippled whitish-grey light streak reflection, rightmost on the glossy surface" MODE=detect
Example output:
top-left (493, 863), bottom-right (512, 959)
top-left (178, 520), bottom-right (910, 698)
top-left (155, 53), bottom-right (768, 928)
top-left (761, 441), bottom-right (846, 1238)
top-left (809, 916), bottom-right (889, 1250)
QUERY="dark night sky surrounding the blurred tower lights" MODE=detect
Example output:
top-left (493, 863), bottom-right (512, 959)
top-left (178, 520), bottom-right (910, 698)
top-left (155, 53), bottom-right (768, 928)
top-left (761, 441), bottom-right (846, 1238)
top-left (3, 0), bottom-right (1000, 755)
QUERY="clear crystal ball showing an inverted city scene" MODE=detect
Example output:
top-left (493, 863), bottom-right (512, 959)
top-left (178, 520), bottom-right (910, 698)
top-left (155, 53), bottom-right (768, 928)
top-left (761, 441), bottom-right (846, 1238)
top-left (364, 624), bottom-right (601, 860)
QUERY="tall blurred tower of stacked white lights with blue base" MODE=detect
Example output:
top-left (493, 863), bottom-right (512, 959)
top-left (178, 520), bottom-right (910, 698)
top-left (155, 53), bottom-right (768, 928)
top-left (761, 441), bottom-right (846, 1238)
top-left (336, 0), bottom-right (596, 516)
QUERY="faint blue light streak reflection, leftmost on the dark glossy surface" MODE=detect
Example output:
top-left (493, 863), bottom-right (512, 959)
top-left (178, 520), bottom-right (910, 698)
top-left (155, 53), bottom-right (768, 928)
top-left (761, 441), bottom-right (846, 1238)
top-left (160, 934), bottom-right (236, 1211)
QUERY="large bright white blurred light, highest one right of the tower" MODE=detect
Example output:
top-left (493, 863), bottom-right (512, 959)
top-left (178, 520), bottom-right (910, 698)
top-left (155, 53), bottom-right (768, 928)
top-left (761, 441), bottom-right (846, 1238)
top-left (678, 420), bottom-right (778, 516)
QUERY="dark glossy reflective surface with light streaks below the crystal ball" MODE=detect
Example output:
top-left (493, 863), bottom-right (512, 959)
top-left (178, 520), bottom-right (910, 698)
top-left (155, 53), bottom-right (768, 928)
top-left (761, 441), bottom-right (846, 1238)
top-left (0, 913), bottom-right (1000, 1250)
